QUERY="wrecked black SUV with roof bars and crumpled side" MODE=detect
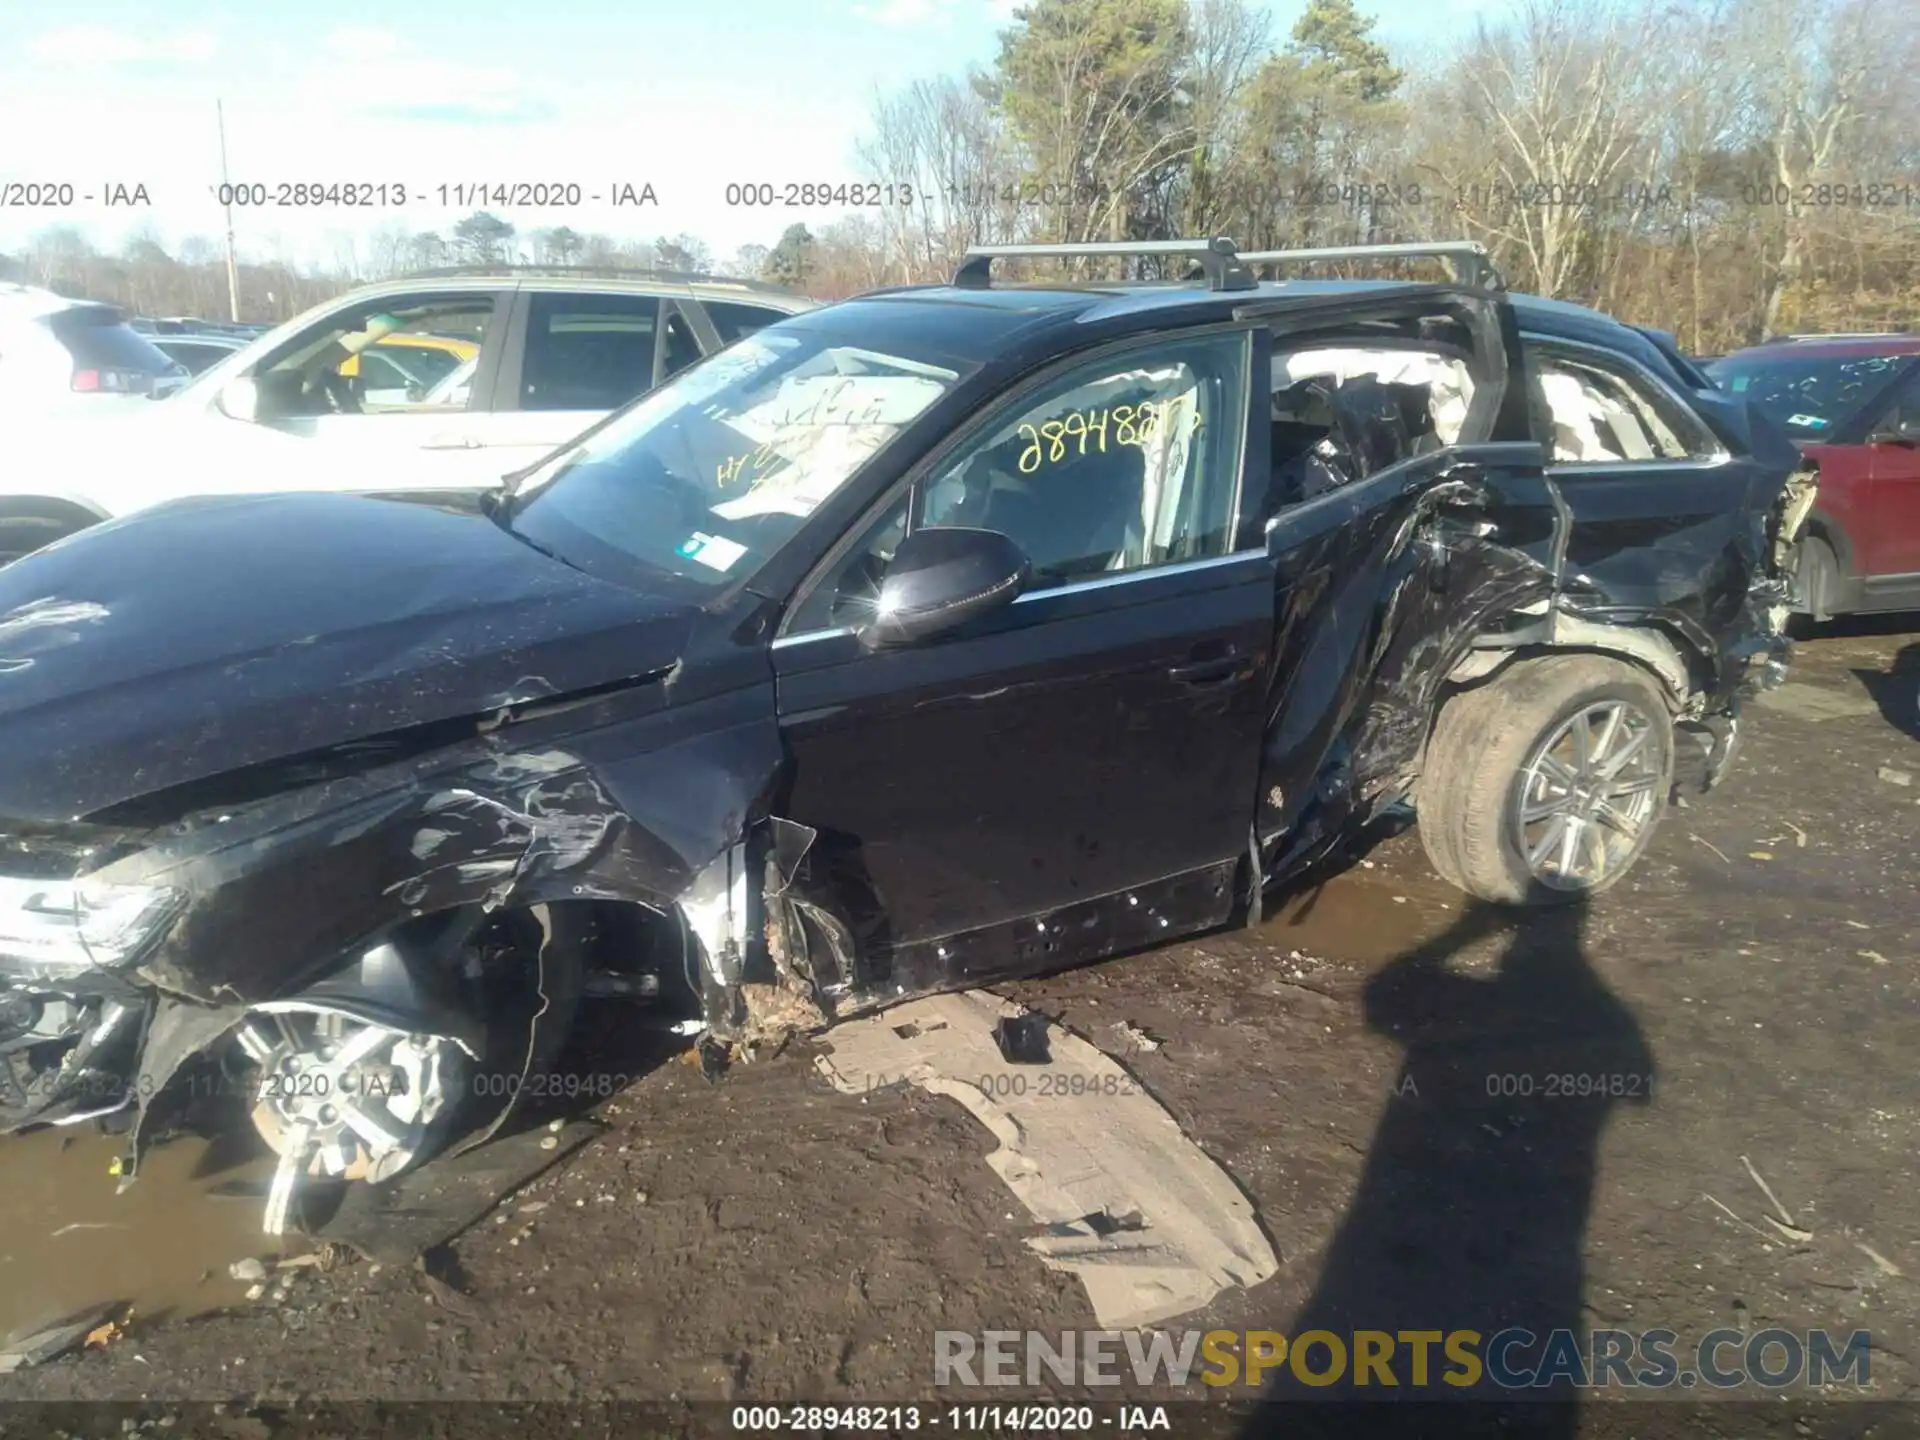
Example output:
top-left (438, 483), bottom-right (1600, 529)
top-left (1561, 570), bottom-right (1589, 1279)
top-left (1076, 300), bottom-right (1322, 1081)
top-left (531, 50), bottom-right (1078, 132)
top-left (0, 240), bottom-right (1812, 1231)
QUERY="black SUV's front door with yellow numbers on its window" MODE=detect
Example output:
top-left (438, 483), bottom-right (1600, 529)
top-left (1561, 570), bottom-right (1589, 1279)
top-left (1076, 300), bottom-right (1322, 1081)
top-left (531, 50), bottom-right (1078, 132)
top-left (774, 330), bottom-right (1273, 985)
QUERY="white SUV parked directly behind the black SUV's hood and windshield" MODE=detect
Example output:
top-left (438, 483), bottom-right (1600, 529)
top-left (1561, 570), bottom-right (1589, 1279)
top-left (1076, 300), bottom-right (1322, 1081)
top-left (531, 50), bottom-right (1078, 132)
top-left (0, 267), bottom-right (812, 564)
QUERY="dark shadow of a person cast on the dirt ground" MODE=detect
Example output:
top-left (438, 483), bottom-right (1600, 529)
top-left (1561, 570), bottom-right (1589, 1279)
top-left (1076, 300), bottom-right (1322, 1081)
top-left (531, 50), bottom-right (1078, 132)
top-left (1248, 902), bottom-right (1653, 1436)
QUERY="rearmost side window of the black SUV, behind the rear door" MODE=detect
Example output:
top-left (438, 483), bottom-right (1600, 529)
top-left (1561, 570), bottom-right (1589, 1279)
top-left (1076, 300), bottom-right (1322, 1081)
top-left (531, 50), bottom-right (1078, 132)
top-left (1532, 348), bottom-right (1718, 465)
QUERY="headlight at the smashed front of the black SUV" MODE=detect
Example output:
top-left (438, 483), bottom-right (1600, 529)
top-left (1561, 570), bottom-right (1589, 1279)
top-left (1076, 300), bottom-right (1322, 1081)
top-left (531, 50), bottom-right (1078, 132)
top-left (0, 876), bottom-right (184, 981)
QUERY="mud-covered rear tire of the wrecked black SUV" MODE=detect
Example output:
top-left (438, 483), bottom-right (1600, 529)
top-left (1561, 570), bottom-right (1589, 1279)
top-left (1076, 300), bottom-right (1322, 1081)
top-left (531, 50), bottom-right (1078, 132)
top-left (1417, 655), bottom-right (1674, 904)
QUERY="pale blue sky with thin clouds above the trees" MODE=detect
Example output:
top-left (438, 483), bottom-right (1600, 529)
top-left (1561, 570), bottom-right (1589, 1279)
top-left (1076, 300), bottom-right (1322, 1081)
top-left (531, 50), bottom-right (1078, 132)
top-left (0, 0), bottom-right (1500, 261)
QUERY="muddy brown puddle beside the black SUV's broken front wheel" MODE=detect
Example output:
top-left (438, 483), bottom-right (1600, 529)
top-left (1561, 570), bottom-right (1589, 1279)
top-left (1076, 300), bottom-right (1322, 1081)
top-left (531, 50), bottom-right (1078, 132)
top-left (0, 1125), bottom-right (288, 1338)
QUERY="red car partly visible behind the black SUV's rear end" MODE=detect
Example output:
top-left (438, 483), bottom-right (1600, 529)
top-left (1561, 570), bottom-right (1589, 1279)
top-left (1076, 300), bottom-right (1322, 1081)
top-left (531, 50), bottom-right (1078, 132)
top-left (1707, 334), bottom-right (1920, 620)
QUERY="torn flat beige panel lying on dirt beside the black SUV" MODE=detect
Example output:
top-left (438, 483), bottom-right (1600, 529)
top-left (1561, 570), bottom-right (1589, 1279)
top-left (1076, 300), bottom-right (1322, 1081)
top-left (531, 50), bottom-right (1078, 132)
top-left (814, 991), bottom-right (1279, 1329)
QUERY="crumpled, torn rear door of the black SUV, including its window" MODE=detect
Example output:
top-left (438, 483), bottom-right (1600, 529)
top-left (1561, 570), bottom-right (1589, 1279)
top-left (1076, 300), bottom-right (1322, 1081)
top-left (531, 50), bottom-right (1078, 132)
top-left (1250, 286), bottom-right (1563, 856)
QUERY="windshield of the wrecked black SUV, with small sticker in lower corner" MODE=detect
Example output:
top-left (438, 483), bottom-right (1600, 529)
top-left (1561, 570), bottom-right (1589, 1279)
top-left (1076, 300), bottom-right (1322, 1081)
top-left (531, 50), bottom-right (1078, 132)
top-left (509, 326), bottom-right (960, 588)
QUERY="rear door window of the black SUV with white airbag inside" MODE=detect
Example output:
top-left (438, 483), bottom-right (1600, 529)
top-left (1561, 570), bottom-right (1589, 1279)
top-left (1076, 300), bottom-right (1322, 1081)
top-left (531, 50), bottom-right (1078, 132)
top-left (1271, 340), bottom-right (1473, 505)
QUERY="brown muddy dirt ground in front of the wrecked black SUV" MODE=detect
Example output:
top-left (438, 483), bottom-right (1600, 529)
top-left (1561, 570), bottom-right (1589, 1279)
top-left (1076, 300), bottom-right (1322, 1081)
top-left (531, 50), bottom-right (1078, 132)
top-left (0, 622), bottom-right (1920, 1434)
